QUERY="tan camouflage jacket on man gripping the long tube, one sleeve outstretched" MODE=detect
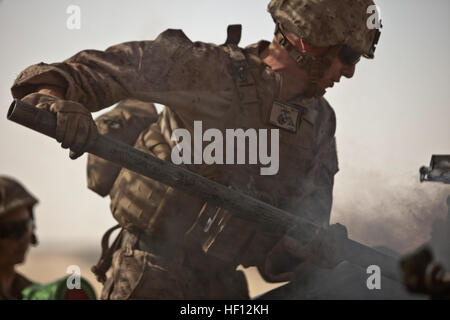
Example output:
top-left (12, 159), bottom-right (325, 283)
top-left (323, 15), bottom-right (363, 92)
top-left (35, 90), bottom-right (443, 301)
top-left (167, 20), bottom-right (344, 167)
top-left (12, 30), bottom-right (338, 272)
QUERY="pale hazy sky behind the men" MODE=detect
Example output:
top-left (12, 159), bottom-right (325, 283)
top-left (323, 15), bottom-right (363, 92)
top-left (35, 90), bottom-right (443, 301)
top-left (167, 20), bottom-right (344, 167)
top-left (0, 0), bottom-right (450, 250)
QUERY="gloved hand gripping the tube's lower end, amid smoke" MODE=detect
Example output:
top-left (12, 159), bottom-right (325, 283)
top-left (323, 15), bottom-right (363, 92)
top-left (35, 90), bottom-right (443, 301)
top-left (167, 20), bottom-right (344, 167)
top-left (264, 223), bottom-right (348, 282)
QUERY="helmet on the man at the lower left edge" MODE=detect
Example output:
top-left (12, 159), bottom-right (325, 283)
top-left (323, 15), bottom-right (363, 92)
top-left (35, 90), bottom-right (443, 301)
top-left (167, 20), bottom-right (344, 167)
top-left (0, 176), bottom-right (38, 216)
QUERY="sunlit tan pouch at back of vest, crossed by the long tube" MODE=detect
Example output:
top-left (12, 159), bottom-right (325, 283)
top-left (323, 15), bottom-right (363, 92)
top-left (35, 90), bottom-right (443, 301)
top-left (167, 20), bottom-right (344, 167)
top-left (110, 119), bottom-right (206, 242)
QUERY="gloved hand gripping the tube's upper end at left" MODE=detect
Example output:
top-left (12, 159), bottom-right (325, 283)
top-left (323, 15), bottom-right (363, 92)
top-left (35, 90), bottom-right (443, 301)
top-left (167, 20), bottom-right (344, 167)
top-left (21, 93), bottom-right (98, 159)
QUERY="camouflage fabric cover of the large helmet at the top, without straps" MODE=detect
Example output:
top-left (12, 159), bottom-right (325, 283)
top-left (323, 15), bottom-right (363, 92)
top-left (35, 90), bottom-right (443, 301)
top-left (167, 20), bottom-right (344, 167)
top-left (268, 0), bottom-right (379, 58)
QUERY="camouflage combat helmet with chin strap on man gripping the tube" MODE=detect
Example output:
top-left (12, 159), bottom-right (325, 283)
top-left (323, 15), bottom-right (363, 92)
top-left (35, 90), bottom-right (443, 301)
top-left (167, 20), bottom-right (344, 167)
top-left (268, 0), bottom-right (382, 96)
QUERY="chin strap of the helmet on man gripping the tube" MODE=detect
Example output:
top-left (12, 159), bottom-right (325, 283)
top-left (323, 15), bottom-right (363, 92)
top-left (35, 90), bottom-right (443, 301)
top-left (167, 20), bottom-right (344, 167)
top-left (275, 23), bottom-right (342, 98)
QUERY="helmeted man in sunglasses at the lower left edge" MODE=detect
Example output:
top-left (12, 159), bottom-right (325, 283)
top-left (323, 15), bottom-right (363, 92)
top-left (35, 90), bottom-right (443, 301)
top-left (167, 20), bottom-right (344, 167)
top-left (0, 176), bottom-right (38, 300)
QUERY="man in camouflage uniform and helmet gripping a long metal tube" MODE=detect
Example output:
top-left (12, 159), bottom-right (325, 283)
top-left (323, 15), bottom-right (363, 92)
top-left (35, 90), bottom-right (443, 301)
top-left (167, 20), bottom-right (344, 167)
top-left (12, 0), bottom-right (378, 299)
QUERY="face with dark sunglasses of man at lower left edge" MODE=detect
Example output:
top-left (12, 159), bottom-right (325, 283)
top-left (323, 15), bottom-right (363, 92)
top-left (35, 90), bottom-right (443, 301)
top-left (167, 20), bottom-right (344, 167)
top-left (0, 207), bottom-right (33, 267)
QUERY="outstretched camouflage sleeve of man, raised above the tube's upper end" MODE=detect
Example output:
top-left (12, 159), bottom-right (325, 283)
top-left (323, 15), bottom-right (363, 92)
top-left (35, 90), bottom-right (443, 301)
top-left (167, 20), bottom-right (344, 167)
top-left (11, 29), bottom-right (236, 117)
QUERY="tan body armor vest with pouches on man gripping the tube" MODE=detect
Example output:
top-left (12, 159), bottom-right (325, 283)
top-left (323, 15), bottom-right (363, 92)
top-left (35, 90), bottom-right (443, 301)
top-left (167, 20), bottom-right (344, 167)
top-left (104, 39), bottom-right (337, 265)
